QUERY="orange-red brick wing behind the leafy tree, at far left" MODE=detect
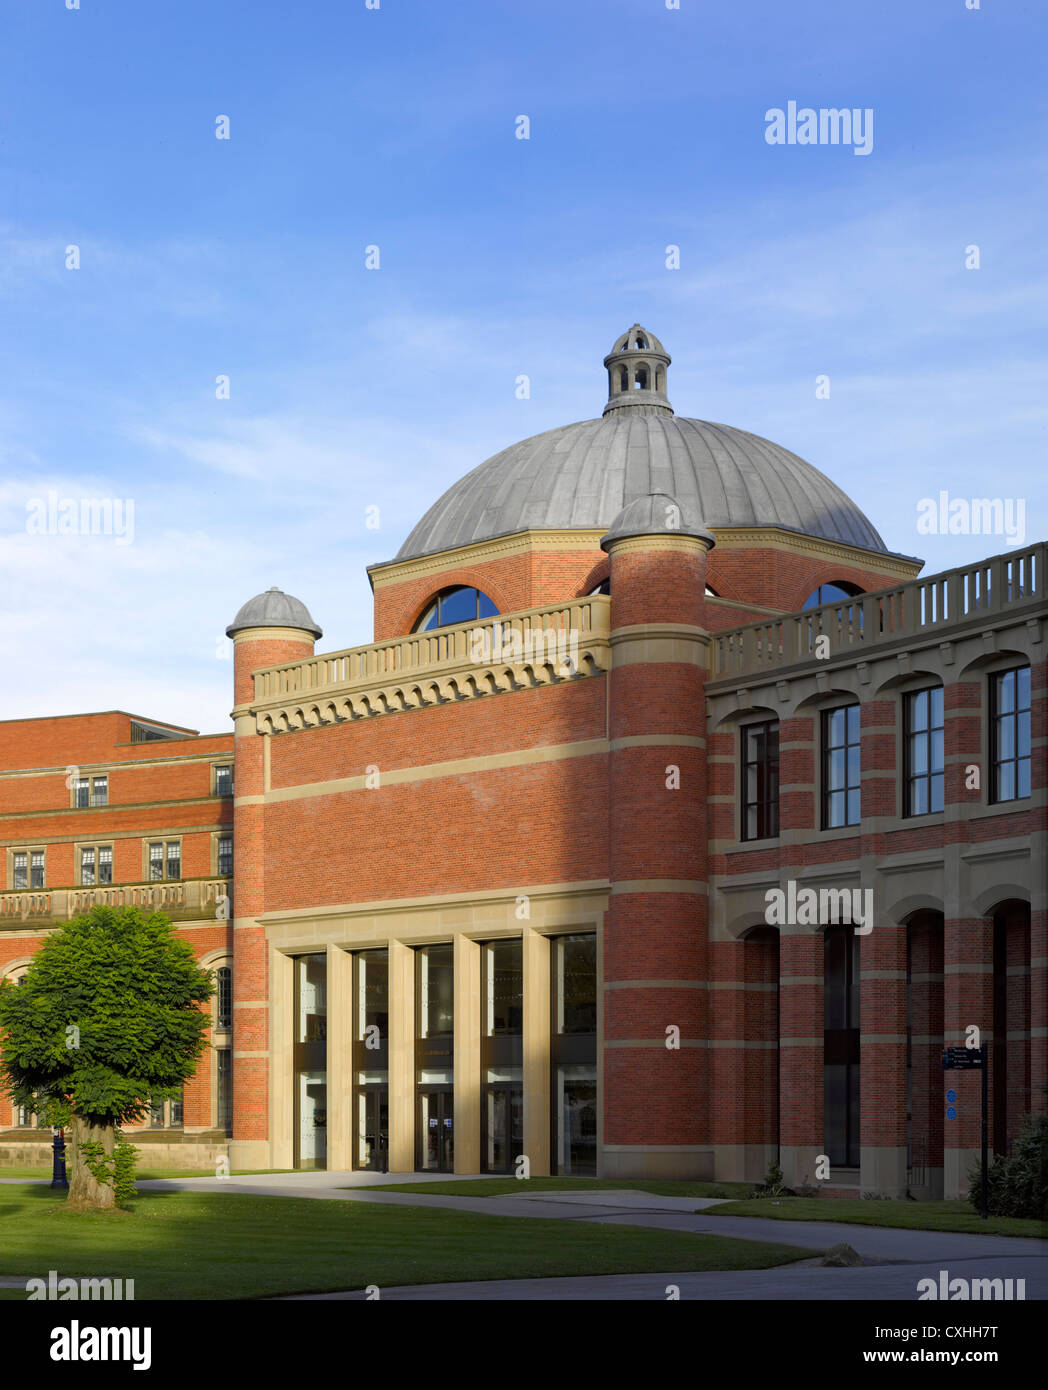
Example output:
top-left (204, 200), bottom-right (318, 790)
top-left (0, 710), bottom-right (234, 1166)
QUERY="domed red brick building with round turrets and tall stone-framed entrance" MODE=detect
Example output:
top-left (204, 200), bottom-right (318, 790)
top-left (0, 325), bottom-right (1048, 1195)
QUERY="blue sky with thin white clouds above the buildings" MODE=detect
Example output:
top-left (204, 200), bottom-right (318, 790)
top-left (0, 0), bottom-right (1048, 731)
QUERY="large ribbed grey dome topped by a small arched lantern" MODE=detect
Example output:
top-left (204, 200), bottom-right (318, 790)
top-left (396, 324), bottom-right (888, 560)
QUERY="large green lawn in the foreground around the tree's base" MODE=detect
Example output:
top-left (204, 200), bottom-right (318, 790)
top-left (0, 1184), bottom-right (813, 1301)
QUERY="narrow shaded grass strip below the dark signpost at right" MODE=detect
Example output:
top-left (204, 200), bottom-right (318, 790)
top-left (702, 1197), bottom-right (1048, 1238)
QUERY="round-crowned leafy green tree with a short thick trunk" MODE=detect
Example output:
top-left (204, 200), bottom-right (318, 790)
top-left (0, 906), bottom-right (214, 1209)
